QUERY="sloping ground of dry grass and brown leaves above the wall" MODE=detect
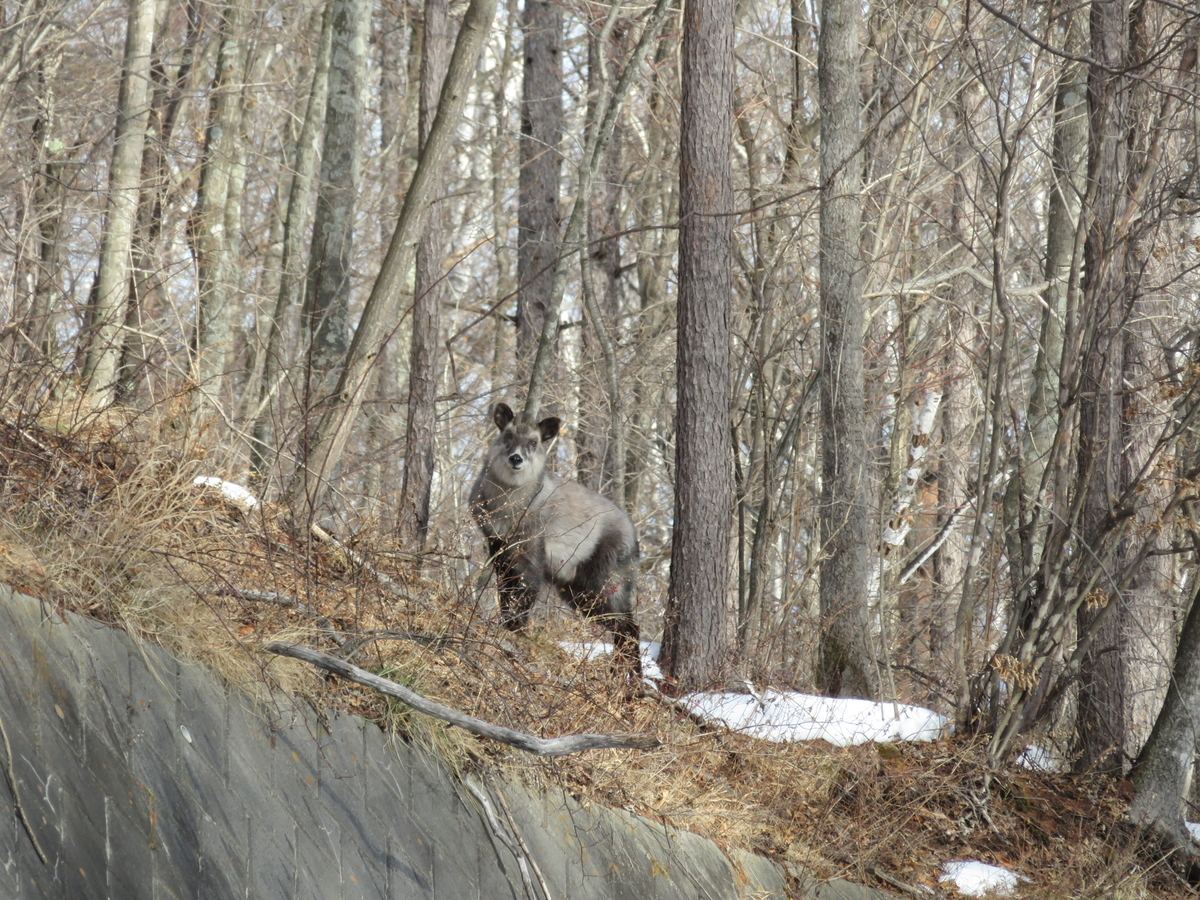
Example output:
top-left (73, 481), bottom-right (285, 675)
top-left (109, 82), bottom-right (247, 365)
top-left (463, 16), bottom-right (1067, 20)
top-left (0, 403), bottom-right (1192, 900)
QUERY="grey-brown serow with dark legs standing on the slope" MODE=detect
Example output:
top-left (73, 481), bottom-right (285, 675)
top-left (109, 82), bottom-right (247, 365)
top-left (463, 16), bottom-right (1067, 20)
top-left (470, 403), bottom-right (642, 676)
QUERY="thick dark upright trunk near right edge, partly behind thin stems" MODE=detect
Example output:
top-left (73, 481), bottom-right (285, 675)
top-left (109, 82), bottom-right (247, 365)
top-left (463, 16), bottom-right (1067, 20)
top-left (1076, 2), bottom-right (1146, 773)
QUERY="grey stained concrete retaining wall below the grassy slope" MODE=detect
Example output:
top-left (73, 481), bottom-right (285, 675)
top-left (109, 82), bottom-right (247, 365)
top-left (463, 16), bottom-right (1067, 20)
top-left (0, 586), bottom-right (892, 900)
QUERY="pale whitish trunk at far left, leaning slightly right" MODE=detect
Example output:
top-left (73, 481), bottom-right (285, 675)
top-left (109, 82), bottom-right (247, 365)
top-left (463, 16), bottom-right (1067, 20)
top-left (83, 0), bottom-right (155, 406)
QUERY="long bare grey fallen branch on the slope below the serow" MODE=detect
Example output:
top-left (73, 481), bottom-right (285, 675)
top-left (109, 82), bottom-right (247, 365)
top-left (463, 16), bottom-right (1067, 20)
top-left (263, 641), bottom-right (659, 756)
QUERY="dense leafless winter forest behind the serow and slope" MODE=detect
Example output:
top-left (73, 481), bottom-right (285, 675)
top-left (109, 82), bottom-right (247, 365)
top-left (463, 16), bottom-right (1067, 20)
top-left (0, 0), bottom-right (1200, 854)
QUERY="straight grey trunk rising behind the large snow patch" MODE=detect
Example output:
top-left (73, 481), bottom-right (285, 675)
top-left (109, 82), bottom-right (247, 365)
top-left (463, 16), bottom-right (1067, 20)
top-left (817, 0), bottom-right (878, 698)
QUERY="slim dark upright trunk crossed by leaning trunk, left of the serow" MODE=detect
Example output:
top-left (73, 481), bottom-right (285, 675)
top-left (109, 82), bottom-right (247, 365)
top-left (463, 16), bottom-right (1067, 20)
top-left (400, 0), bottom-right (450, 546)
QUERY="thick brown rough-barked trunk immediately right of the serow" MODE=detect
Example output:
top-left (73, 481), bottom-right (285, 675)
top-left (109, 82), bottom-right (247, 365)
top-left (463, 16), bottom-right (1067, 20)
top-left (662, 0), bottom-right (734, 690)
